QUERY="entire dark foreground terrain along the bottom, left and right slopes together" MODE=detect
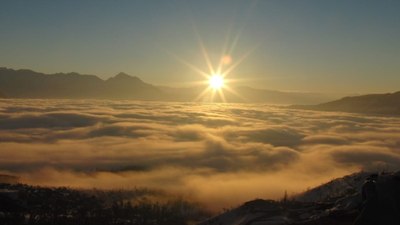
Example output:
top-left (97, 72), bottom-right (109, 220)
top-left (0, 172), bottom-right (400, 225)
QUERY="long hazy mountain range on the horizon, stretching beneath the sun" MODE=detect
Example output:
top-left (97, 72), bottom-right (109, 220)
top-left (0, 68), bottom-right (337, 104)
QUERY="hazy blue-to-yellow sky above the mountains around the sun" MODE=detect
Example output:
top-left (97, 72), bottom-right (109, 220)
top-left (0, 0), bottom-right (400, 93)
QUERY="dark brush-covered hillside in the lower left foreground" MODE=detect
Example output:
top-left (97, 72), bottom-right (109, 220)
top-left (0, 183), bottom-right (209, 225)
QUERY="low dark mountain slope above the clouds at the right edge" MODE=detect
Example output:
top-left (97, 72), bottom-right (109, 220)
top-left (292, 91), bottom-right (400, 115)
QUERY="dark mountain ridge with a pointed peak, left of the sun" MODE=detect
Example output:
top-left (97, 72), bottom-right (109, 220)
top-left (0, 68), bottom-right (163, 100)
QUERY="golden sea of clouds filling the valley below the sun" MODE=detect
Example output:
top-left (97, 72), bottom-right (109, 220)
top-left (0, 99), bottom-right (400, 209)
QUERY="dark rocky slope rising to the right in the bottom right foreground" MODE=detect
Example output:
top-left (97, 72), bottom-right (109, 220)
top-left (199, 171), bottom-right (400, 225)
